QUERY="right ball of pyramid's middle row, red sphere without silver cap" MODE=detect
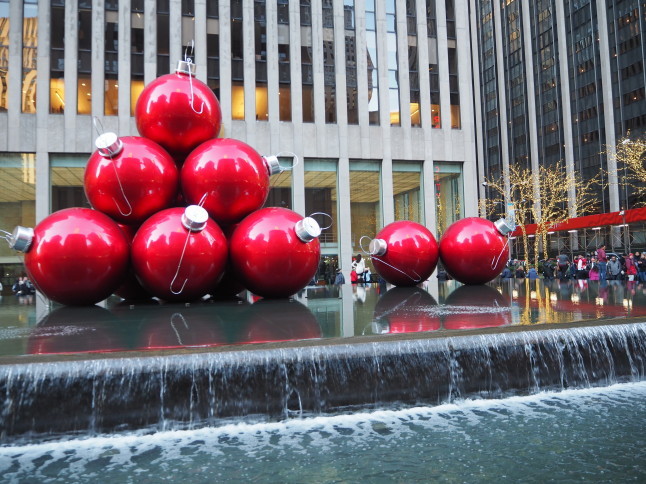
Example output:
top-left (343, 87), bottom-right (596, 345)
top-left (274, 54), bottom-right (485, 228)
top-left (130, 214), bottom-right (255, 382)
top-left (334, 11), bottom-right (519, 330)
top-left (180, 138), bottom-right (269, 224)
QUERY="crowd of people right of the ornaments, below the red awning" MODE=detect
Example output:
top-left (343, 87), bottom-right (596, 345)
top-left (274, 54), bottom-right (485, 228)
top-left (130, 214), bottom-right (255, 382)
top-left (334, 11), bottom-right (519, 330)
top-left (501, 245), bottom-right (646, 282)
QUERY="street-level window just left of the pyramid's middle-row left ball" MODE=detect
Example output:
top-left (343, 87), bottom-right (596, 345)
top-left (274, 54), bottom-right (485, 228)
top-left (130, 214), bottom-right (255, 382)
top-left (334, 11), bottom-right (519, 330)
top-left (50, 154), bottom-right (90, 212)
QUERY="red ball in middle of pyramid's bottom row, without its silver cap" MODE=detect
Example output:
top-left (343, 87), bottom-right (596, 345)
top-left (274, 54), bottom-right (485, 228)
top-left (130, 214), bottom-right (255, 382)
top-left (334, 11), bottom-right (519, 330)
top-left (132, 207), bottom-right (227, 302)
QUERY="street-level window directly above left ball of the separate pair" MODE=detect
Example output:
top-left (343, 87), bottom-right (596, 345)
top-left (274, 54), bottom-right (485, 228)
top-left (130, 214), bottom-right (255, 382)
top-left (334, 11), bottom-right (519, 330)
top-left (393, 161), bottom-right (424, 224)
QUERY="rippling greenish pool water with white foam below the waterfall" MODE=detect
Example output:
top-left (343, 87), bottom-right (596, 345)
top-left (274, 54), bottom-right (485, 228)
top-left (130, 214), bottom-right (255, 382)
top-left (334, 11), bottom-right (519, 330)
top-left (0, 382), bottom-right (646, 484)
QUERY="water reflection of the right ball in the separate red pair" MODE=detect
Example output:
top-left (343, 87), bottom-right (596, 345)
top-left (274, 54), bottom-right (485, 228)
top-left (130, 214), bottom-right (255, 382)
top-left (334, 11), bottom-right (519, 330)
top-left (442, 285), bottom-right (511, 329)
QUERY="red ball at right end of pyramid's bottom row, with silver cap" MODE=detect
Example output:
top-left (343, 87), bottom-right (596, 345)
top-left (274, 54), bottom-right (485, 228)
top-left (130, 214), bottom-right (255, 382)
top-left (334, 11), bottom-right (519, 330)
top-left (230, 208), bottom-right (321, 298)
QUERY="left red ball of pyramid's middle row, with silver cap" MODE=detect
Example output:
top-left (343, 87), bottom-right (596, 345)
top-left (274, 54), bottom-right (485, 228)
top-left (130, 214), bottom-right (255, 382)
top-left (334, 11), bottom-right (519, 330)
top-left (83, 133), bottom-right (179, 225)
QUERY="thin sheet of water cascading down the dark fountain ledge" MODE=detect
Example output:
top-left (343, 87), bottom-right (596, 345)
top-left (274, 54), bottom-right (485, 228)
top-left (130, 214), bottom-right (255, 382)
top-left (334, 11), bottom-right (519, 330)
top-left (0, 320), bottom-right (646, 443)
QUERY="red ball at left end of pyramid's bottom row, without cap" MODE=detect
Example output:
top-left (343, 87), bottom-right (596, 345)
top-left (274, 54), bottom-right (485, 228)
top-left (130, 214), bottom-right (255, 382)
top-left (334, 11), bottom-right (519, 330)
top-left (25, 208), bottom-right (130, 305)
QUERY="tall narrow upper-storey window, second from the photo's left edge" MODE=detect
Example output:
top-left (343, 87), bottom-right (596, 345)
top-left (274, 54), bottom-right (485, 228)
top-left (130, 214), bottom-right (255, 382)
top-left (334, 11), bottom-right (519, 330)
top-left (21, 0), bottom-right (38, 113)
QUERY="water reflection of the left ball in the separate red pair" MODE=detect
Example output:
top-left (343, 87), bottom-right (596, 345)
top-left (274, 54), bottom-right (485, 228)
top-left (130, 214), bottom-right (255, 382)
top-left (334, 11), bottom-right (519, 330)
top-left (373, 287), bottom-right (442, 333)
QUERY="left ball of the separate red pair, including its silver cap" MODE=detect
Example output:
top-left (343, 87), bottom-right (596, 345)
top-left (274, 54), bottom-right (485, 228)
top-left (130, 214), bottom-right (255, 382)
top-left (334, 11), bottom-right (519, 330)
top-left (370, 220), bottom-right (439, 286)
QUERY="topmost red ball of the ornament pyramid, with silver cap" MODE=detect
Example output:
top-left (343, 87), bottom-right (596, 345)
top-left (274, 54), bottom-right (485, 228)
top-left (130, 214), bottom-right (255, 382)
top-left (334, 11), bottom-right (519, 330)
top-left (135, 61), bottom-right (222, 164)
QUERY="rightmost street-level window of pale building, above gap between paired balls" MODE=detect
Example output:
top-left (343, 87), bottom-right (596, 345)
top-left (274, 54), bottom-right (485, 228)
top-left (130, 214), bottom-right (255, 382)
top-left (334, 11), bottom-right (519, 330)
top-left (434, 162), bottom-right (464, 237)
